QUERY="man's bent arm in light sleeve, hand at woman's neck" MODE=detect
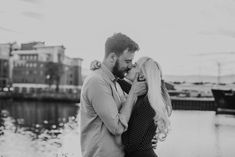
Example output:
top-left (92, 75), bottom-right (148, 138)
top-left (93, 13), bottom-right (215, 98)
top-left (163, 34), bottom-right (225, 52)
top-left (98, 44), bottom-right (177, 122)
top-left (87, 78), bottom-right (142, 135)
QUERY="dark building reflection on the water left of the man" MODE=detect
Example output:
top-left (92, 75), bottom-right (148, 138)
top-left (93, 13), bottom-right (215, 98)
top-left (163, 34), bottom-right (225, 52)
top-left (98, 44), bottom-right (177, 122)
top-left (0, 101), bottom-right (78, 129)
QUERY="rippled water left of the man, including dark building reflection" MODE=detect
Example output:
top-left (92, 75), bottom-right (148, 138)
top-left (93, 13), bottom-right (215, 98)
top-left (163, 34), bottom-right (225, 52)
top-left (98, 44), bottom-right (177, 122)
top-left (0, 101), bottom-right (79, 157)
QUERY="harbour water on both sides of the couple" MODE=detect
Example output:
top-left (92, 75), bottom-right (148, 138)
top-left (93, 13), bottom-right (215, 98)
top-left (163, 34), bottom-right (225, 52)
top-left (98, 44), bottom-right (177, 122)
top-left (0, 102), bottom-right (235, 157)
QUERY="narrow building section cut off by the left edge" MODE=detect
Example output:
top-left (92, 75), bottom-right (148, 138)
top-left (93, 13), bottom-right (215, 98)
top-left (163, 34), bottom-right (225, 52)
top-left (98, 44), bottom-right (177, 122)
top-left (0, 42), bottom-right (18, 91)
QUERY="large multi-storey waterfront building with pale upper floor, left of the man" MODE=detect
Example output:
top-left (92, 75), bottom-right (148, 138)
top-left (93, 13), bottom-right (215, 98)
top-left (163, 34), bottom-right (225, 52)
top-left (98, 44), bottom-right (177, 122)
top-left (12, 42), bottom-right (83, 92)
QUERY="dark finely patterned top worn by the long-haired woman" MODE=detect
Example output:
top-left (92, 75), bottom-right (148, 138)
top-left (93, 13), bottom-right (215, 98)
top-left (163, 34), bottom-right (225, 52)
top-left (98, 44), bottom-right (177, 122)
top-left (118, 81), bottom-right (157, 157)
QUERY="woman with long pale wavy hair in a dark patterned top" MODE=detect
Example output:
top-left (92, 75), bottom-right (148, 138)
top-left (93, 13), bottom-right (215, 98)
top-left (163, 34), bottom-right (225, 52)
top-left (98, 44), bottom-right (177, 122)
top-left (119, 57), bottom-right (172, 157)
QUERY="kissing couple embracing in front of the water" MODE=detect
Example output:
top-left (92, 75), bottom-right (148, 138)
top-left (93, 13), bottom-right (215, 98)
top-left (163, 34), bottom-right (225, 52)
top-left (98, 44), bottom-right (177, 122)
top-left (79, 33), bottom-right (172, 157)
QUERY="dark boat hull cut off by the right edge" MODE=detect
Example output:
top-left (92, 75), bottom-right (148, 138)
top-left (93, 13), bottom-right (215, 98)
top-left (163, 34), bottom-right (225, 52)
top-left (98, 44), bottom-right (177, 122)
top-left (212, 89), bottom-right (235, 115)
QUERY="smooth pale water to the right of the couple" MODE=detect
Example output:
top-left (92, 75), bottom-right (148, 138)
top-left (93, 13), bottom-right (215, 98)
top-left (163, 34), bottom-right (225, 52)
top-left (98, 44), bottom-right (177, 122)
top-left (156, 111), bottom-right (235, 157)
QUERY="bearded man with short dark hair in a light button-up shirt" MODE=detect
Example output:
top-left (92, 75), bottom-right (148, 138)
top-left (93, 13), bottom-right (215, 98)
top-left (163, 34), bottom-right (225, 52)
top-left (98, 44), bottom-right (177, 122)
top-left (80, 33), bottom-right (146, 157)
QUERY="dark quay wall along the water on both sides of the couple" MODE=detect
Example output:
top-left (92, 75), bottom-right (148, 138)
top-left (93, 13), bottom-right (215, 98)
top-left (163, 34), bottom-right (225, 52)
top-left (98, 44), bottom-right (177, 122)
top-left (0, 92), bottom-right (216, 111)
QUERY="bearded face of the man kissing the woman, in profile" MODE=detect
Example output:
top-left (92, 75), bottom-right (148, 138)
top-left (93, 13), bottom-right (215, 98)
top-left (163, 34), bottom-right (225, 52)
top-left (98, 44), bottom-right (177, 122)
top-left (113, 49), bottom-right (135, 79)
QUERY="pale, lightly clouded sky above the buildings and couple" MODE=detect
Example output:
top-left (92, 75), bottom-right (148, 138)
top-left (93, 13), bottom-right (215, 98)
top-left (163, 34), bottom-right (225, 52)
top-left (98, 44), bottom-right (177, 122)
top-left (0, 0), bottom-right (235, 75)
